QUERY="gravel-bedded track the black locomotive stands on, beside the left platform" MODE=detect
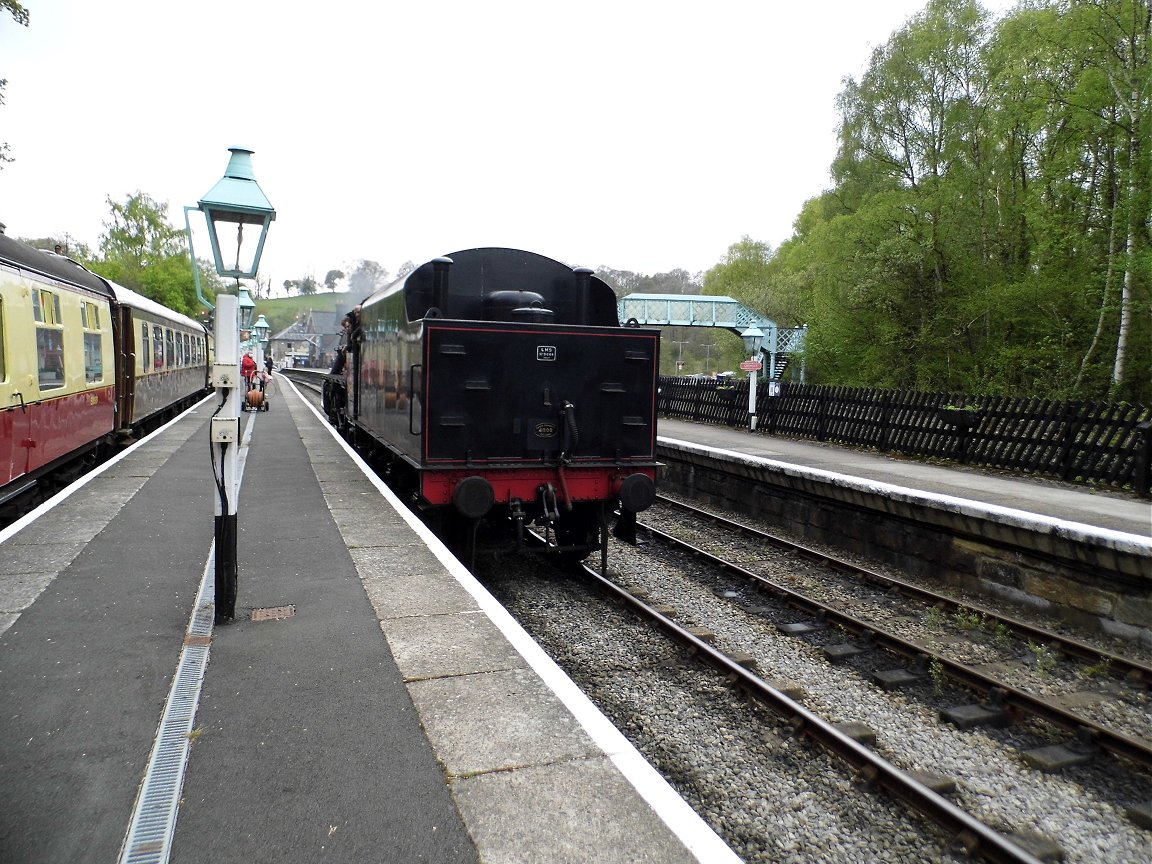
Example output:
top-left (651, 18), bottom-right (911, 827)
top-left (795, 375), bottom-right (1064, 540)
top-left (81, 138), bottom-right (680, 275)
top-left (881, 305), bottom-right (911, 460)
top-left (482, 532), bottom-right (1144, 864)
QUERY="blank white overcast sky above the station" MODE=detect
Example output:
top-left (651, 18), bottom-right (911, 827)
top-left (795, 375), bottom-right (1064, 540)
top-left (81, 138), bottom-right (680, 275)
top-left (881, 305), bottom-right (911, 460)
top-left (0, 0), bottom-right (1008, 288)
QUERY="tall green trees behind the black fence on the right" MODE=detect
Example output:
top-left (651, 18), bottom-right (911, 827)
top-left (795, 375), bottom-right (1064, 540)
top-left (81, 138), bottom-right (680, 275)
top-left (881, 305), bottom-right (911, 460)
top-left (755, 0), bottom-right (1152, 402)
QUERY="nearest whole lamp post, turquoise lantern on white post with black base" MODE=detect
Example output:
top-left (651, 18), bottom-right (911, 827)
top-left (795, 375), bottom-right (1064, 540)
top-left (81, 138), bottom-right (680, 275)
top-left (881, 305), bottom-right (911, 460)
top-left (184, 147), bottom-right (276, 624)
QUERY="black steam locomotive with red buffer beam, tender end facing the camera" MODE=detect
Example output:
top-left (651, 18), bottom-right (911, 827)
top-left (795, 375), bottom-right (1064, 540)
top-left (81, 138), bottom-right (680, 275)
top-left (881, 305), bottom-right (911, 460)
top-left (324, 248), bottom-right (660, 567)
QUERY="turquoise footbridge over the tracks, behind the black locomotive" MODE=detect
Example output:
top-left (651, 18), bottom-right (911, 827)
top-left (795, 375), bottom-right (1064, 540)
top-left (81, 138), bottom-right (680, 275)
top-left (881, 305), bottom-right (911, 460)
top-left (616, 294), bottom-right (808, 384)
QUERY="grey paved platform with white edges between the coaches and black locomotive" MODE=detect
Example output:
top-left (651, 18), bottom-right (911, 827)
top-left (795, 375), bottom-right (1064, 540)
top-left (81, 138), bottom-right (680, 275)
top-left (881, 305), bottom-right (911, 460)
top-left (0, 376), bottom-right (738, 864)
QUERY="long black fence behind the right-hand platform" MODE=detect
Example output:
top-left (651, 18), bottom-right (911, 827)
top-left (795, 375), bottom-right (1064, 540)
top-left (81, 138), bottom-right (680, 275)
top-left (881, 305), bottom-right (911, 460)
top-left (659, 378), bottom-right (1152, 497)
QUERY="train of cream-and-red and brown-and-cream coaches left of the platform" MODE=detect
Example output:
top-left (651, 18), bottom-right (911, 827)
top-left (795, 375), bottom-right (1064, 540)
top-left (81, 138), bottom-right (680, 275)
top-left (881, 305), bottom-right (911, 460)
top-left (0, 234), bottom-right (210, 524)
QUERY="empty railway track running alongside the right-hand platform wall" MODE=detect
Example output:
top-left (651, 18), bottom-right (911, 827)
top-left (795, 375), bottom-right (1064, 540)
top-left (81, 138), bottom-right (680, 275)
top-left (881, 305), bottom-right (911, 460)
top-left (643, 499), bottom-right (1152, 770)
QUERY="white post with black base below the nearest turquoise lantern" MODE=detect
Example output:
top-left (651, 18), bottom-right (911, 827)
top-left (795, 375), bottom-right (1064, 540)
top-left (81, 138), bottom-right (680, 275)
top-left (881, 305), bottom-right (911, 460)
top-left (211, 294), bottom-right (242, 624)
